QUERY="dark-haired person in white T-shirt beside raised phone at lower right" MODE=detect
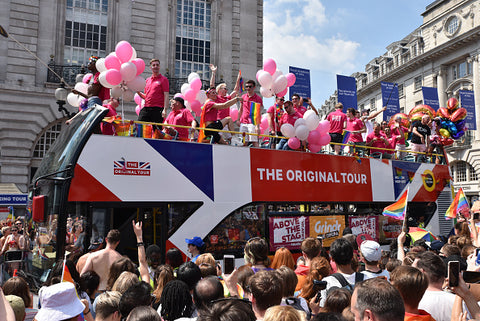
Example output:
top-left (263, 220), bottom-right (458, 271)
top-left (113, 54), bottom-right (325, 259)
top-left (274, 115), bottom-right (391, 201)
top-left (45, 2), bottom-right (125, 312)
top-left (413, 251), bottom-right (455, 321)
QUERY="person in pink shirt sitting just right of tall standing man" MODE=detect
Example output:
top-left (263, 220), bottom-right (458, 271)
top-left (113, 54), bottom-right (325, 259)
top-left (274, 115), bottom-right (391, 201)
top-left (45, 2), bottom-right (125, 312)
top-left (165, 97), bottom-right (196, 141)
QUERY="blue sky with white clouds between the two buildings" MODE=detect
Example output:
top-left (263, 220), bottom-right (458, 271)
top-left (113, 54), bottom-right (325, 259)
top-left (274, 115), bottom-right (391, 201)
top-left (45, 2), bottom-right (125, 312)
top-left (263, 0), bottom-right (433, 107)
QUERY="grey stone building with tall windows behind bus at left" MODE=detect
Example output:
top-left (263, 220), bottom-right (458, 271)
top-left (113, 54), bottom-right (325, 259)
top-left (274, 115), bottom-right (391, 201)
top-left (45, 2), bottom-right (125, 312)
top-left (0, 0), bottom-right (263, 192)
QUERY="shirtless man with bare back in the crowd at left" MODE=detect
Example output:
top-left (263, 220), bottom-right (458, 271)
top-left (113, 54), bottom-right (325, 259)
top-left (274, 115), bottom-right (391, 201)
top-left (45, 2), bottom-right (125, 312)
top-left (80, 230), bottom-right (123, 291)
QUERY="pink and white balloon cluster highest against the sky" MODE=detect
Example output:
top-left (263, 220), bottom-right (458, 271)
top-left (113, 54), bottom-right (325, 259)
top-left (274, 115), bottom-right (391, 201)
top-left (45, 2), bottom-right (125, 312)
top-left (257, 58), bottom-right (297, 98)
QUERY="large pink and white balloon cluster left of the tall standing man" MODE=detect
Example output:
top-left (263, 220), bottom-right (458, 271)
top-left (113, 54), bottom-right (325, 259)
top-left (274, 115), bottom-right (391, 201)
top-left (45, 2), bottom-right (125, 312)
top-left (95, 40), bottom-right (145, 101)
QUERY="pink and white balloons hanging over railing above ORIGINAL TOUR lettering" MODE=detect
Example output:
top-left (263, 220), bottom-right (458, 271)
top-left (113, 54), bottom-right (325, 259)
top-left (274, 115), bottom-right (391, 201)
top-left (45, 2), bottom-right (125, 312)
top-left (280, 110), bottom-right (330, 153)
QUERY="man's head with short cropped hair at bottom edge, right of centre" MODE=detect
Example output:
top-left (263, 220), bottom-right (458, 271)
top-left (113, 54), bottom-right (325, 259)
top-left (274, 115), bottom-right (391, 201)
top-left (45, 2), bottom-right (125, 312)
top-left (351, 278), bottom-right (405, 321)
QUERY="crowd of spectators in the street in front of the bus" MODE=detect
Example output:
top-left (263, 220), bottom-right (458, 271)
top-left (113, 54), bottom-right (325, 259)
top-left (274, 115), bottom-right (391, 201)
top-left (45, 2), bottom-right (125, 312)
top-left (0, 210), bottom-right (480, 321)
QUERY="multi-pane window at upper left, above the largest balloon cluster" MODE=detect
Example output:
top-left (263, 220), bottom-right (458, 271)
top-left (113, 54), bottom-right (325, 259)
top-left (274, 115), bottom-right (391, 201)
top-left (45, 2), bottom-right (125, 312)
top-left (64, 0), bottom-right (108, 65)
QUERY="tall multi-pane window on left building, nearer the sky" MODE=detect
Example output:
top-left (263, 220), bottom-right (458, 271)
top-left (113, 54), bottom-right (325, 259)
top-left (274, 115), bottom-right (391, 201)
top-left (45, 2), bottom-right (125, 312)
top-left (175, 0), bottom-right (211, 79)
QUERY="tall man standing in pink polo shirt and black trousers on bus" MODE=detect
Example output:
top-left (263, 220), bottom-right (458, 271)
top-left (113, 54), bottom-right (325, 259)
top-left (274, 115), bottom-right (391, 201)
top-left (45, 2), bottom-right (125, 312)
top-left (137, 58), bottom-right (170, 129)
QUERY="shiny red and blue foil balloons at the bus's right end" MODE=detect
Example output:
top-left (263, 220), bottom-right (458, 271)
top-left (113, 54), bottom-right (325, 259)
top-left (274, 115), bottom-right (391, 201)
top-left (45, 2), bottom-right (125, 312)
top-left (437, 98), bottom-right (467, 139)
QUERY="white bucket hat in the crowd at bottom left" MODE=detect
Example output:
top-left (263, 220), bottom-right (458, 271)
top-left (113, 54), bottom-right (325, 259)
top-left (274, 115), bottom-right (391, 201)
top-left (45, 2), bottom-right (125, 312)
top-left (35, 282), bottom-right (85, 321)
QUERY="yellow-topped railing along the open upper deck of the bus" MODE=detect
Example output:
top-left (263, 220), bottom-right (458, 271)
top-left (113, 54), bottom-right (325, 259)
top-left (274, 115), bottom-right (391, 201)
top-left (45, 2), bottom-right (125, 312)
top-left (106, 119), bottom-right (445, 164)
